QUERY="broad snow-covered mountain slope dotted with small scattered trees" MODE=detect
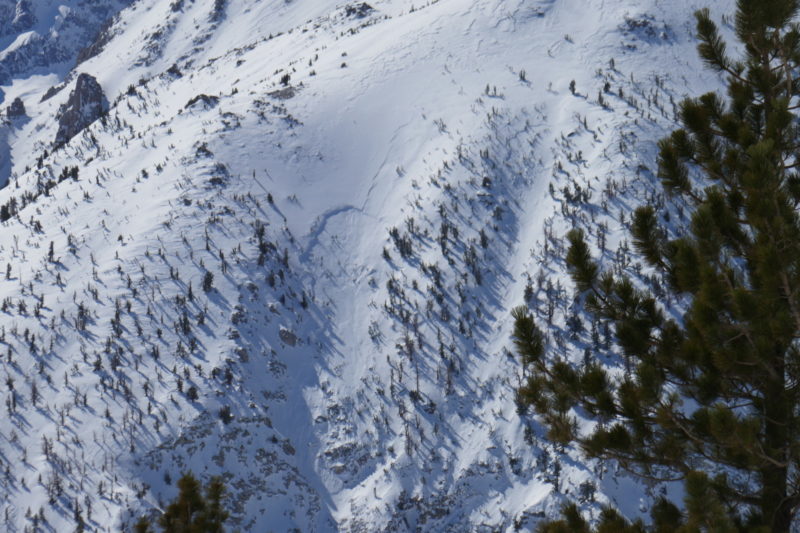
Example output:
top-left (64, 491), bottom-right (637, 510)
top-left (0, 0), bottom-right (732, 531)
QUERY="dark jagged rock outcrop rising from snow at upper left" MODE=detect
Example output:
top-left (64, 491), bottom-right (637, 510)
top-left (55, 73), bottom-right (108, 146)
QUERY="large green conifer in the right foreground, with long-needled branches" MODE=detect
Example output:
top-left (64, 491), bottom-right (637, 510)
top-left (513, 0), bottom-right (800, 533)
